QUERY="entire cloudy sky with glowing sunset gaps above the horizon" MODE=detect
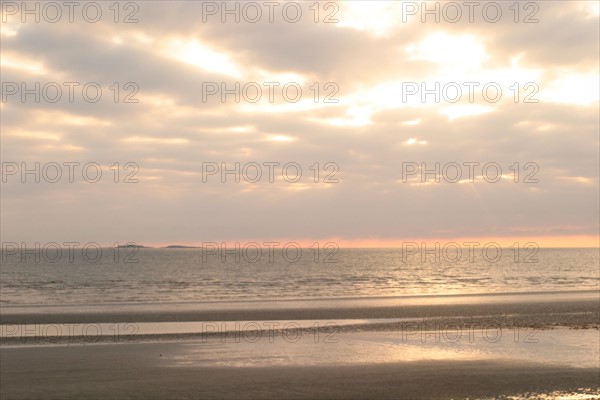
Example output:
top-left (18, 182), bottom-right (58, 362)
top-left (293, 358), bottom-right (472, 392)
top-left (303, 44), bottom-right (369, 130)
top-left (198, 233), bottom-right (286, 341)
top-left (1, 1), bottom-right (599, 246)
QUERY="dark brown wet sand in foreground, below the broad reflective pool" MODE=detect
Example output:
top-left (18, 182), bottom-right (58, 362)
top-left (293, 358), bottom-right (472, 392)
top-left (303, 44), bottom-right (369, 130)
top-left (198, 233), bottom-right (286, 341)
top-left (0, 343), bottom-right (599, 399)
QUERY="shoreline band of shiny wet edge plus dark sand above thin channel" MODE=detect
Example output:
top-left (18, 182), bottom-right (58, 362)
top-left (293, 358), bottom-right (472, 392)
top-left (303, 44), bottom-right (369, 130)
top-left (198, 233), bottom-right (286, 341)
top-left (0, 290), bottom-right (600, 324)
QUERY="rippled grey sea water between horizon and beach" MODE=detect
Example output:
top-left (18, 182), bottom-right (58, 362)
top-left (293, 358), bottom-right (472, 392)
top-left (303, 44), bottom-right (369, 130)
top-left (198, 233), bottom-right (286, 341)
top-left (0, 248), bottom-right (600, 305)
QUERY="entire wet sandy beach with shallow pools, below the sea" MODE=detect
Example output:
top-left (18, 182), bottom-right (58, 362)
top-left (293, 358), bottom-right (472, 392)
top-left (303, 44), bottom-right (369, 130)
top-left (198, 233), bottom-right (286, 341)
top-left (0, 291), bottom-right (600, 399)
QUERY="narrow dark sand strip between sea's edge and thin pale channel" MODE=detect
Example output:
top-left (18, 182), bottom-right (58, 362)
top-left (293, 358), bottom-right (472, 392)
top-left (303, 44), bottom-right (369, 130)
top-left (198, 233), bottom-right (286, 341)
top-left (0, 297), bottom-right (600, 324)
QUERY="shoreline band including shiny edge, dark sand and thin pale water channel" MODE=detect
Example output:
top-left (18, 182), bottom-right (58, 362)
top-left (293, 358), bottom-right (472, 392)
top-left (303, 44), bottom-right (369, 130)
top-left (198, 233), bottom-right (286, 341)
top-left (0, 292), bottom-right (600, 346)
